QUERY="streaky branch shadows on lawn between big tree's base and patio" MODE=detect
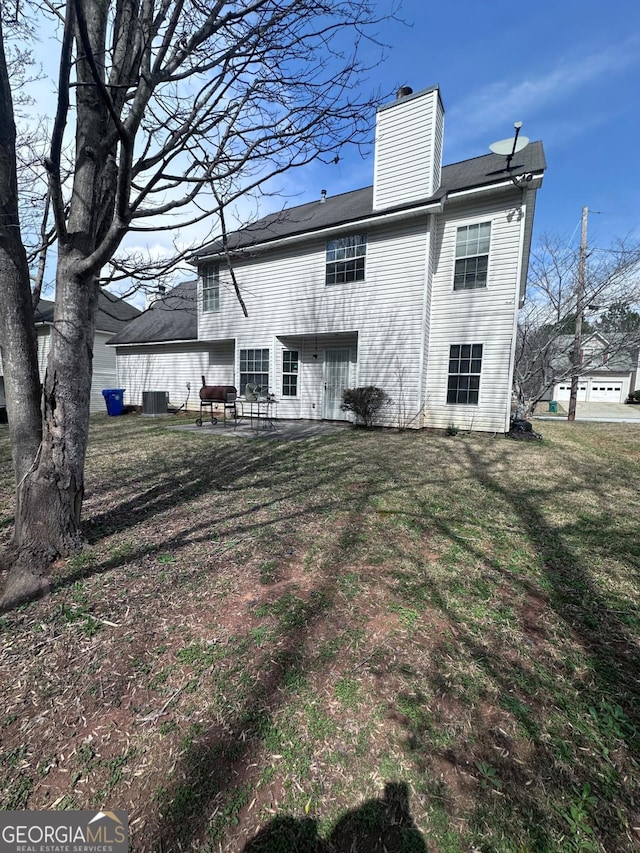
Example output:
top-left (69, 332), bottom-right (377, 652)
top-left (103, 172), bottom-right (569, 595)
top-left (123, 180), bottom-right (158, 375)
top-left (53, 436), bottom-right (410, 590)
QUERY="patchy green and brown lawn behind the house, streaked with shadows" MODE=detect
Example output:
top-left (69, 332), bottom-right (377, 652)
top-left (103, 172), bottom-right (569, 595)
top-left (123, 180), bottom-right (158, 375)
top-left (0, 416), bottom-right (640, 853)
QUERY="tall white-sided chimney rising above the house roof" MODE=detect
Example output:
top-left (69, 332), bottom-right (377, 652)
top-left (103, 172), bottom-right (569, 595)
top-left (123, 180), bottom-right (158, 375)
top-left (373, 86), bottom-right (444, 210)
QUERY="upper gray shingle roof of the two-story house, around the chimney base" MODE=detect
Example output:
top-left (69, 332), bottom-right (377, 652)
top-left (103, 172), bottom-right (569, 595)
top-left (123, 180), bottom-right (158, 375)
top-left (191, 142), bottom-right (546, 264)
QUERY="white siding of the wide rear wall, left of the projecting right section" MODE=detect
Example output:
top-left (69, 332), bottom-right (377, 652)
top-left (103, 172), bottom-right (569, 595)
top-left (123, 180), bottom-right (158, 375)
top-left (198, 217), bottom-right (428, 425)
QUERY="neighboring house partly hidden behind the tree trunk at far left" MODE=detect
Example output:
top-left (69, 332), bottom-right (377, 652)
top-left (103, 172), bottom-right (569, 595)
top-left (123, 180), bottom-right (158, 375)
top-left (0, 290), bottom-right (140, 412)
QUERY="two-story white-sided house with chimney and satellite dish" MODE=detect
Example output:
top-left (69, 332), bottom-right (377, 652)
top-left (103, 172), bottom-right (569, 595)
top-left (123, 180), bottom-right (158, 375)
top-left (110, 87), bottom-right (545, 432)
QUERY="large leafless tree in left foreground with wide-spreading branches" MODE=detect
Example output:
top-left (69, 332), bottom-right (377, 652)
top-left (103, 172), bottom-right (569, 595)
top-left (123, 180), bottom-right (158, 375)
top-left (0, 0), bottom-right (394, 606)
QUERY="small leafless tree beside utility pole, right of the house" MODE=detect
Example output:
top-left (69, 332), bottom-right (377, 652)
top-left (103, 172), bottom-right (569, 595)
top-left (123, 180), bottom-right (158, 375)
top-left (514, 235), bottom-right (640, 414)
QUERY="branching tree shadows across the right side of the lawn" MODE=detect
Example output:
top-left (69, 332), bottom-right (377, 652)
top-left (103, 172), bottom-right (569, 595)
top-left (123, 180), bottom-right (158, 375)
top-left (390, 445), bottom-right (640, 853)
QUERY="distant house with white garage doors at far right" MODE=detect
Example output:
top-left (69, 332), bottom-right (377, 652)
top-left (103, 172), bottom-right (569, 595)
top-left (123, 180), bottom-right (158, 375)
top-left (553, 332), bottom-right (640, 403)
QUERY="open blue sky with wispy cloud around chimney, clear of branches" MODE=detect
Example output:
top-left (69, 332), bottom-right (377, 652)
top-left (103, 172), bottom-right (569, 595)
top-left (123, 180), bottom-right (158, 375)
top-left (289, 0), bottom-right (640, 251)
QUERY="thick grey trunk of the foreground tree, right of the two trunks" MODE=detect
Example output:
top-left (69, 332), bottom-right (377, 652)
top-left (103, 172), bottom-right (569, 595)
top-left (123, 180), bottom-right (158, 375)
top-left (0, 0), bottom-right (114, 607)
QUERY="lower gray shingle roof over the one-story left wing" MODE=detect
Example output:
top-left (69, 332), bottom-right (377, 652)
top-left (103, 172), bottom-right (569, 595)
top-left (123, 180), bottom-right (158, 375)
top-left (107, 281), bottom-right (198, 344)
